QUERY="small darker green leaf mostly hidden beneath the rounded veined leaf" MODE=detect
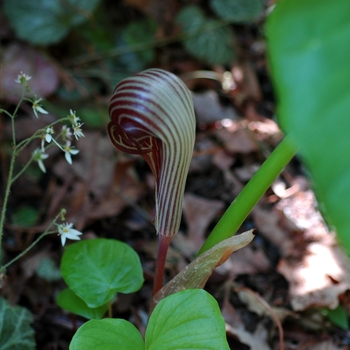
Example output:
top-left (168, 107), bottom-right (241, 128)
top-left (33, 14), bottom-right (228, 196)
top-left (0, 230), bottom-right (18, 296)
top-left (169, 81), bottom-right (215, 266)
top-left (56, 288), bottom-right (108, 320)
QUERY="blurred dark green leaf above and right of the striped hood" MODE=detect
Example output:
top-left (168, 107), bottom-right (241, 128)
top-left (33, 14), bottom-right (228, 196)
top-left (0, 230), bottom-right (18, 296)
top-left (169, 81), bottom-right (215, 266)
top-left (176, 5), bottom-right (235, 64)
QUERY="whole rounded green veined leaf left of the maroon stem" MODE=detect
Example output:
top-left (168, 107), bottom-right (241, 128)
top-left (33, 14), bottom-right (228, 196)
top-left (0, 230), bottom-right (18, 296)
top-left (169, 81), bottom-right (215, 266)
top-left (61, 238), bottom-right (143, 308)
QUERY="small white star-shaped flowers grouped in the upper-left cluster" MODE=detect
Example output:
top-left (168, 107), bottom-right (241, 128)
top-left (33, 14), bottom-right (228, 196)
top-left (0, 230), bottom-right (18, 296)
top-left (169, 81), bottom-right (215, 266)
top-left (15, 72), bottom-right (84, 173)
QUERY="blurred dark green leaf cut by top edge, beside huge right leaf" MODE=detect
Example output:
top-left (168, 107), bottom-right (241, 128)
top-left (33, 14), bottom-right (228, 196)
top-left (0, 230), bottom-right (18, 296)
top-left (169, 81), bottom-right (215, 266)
top-left (210, 0), bottom-right (264, 23)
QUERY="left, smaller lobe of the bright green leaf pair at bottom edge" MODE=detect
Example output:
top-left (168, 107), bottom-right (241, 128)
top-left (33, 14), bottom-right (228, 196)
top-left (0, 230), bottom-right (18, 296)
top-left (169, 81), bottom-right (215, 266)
top-left (69, 318), bottom-right (145, 350)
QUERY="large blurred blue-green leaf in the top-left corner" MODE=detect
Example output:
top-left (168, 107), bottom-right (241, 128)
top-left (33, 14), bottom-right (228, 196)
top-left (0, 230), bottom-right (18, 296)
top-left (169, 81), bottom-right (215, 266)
top-left (4, 0), bottom-right (100, 45)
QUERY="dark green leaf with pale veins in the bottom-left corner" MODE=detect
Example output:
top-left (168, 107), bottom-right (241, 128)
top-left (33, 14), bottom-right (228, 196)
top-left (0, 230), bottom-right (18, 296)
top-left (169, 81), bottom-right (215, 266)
top-left (0, 297), bottom-right (35, 350)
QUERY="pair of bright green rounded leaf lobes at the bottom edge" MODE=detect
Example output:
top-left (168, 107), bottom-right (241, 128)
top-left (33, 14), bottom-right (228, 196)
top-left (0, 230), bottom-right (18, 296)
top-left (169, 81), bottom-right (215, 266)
top-left (70, 289), bottom-right (229, 350)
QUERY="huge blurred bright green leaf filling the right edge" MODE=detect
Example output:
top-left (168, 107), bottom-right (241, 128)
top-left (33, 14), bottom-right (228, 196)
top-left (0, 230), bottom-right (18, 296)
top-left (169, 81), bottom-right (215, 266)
top-left (266, 0), bottom-right (350, 253)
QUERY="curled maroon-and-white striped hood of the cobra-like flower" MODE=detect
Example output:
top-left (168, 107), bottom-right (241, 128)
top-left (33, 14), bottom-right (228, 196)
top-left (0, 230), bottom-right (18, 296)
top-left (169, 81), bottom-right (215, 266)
top-left (108, 69), bottom-right (195, 237)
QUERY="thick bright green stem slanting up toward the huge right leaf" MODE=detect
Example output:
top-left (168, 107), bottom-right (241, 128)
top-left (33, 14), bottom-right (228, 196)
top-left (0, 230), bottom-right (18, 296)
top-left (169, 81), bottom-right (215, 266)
top-left (197, 137), bottom-right (297, 255)
